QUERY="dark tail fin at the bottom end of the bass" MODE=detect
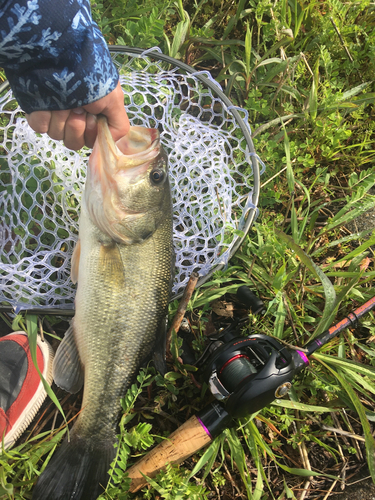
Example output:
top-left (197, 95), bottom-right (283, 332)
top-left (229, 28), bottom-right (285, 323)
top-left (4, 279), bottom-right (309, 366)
top-left (32, 429), bottom-right (116, 500)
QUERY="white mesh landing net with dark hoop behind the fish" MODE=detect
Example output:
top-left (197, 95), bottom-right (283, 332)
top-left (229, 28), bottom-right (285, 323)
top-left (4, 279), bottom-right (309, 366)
top-left (0, 47), bottom-right (259, 310)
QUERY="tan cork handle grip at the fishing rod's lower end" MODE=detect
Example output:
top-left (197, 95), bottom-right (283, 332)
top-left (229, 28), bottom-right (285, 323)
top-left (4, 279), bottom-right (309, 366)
top-left (126, 416), bottom-right (211, 493)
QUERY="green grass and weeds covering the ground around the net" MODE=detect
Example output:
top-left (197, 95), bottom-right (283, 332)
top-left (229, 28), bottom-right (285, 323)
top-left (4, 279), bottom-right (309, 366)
top-left (0, 0), bottom-right (375, 500)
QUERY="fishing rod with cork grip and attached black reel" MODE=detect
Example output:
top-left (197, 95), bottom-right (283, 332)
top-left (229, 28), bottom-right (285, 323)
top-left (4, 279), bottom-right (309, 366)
top-left (127, 286), bottom-right (375, 493)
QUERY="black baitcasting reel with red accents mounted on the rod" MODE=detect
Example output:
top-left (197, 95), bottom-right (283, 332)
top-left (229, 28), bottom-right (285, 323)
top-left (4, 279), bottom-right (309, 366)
top-left (197, 286), bottom-right (302, 418)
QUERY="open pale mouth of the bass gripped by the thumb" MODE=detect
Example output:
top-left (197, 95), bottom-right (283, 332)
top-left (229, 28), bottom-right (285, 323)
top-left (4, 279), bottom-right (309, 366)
top-left (97, 115), bottom-right (160, 173)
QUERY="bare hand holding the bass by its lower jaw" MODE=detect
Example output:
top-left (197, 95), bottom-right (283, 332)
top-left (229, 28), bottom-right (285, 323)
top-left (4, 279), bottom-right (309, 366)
top-left (26, 82), bottom-right (130, 150)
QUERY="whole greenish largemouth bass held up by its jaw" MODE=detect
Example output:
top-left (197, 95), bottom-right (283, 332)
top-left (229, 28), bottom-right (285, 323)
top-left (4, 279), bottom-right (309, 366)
top-left (33, 117), bottom-right (173, 500)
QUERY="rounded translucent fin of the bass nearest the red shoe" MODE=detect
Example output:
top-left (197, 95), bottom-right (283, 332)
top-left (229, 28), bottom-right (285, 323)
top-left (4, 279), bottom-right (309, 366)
top-left (53, 326), bottom-right (84, 394)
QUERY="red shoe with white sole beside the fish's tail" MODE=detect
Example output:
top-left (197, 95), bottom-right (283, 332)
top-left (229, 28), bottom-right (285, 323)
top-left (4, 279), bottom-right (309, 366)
top-left (0, 332), bottom-right (53, 451)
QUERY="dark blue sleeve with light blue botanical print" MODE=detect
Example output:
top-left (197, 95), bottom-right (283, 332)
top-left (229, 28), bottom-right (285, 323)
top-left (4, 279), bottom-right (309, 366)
top-left (0, 0), bottom-right (118, 113)
